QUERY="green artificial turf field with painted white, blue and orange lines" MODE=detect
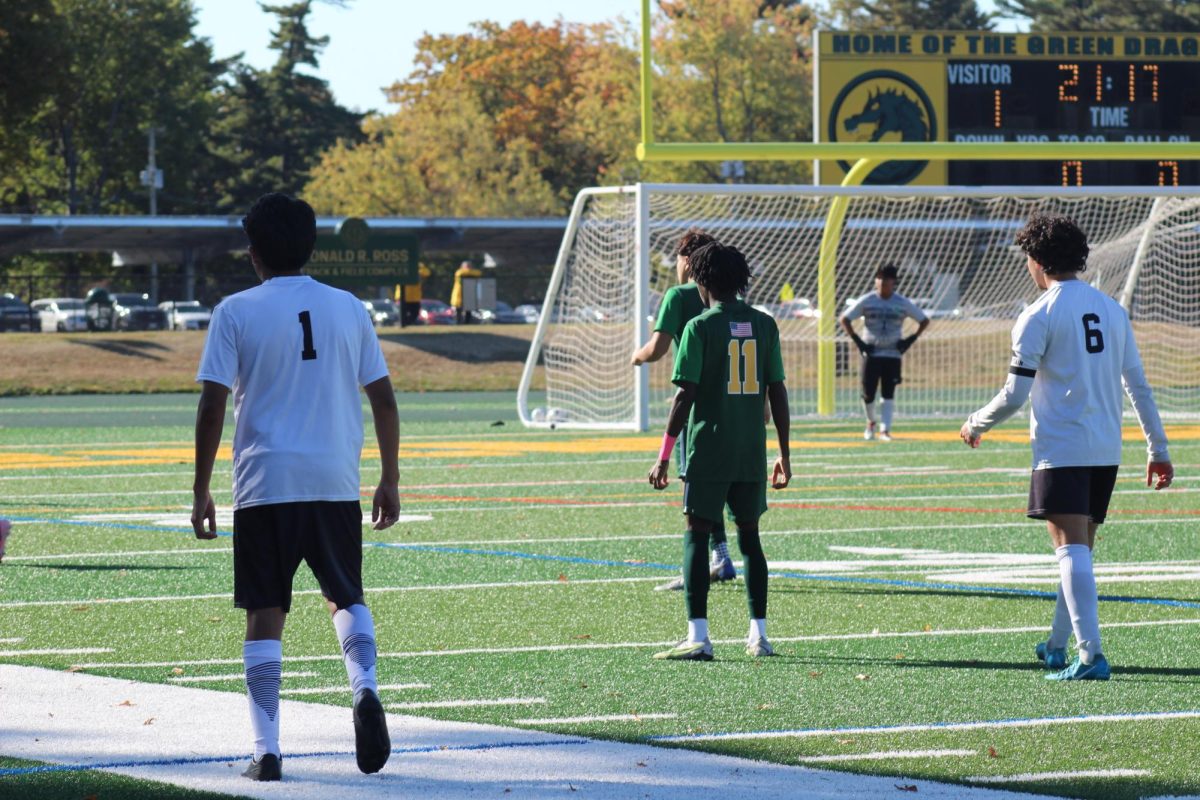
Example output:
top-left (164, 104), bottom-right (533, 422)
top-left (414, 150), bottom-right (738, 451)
top-left (0, 393), bottom-right (1200, 799)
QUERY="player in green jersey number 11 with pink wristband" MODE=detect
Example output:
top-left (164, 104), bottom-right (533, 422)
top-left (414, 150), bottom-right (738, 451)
top-left (649, 242), bottom-right (792, 661)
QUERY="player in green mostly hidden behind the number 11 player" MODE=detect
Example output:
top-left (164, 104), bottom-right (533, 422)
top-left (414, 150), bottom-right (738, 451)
top-left (630, 228), bottom-right (738, 591)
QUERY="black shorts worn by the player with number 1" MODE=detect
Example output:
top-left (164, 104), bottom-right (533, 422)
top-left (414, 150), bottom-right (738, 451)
top-left (233, 500), bottom-right (362, 613)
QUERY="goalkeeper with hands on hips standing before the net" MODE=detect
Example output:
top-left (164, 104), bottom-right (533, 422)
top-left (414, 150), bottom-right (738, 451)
top-left (838, 264), bottom-right (929, 441)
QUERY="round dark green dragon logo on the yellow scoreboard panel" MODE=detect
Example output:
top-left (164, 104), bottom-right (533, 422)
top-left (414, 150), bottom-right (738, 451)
top-left (826, 70), bottom-right (937, 186)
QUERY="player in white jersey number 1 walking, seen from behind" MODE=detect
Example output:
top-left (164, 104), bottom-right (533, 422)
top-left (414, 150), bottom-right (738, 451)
top-left (192, 193), bottom-right (400, 781)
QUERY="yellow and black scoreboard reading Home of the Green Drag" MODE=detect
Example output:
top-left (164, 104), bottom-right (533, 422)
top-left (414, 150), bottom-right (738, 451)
top-left (814, 31), bottom-right (1200, 186)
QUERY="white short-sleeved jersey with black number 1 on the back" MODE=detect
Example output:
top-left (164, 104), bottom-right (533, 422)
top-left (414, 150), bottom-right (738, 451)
top-left (196, 275), bottom-right (388, 509)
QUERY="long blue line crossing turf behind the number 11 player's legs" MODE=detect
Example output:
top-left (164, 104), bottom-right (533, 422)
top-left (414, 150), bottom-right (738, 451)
top-left (10, 517), bottom-right (1200, 608)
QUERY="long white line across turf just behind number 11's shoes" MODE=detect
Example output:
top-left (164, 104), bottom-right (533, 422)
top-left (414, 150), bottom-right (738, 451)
top-left (74, 619), bottom-right (1200, 669)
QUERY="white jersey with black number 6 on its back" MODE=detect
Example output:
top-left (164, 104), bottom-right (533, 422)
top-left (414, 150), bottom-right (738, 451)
top-left (985, 279), bottom-right (1166, 469)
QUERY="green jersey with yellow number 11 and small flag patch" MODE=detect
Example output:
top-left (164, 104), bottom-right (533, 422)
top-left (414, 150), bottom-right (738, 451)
top-left (671, 300), bottom-right (784, 482)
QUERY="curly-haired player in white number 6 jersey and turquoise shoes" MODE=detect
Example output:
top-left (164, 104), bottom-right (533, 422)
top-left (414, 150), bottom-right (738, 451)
top-left (959, 215), bottom-right (1175, 680)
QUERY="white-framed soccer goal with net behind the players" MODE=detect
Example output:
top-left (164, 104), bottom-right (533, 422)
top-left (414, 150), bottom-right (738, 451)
top-left (517, 184), bottom-right (1200, 431)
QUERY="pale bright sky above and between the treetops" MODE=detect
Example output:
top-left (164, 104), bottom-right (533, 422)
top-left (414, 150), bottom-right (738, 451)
top-left (194, 0), bottom-right (1012, 117)
